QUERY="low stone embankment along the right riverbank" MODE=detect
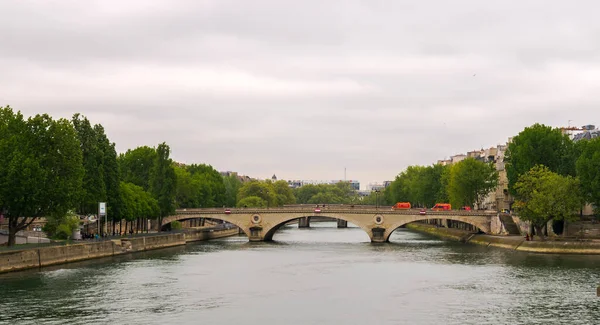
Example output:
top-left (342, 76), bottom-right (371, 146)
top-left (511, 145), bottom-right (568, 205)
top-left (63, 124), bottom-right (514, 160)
top-left (406, 223), bottom-right (600, 255)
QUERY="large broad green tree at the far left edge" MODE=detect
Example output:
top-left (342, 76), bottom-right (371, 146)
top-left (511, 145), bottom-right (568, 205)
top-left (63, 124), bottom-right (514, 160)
top-left (0, 107), bottom-right (84, 245)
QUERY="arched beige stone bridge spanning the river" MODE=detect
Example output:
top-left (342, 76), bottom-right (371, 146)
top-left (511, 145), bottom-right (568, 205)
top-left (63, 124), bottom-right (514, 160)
top-left (161, 207), bottom-right (502, 242)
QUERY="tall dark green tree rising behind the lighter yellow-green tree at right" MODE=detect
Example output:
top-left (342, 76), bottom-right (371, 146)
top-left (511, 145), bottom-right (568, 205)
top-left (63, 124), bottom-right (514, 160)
top-left (505, 124), bottom-right (577, 195)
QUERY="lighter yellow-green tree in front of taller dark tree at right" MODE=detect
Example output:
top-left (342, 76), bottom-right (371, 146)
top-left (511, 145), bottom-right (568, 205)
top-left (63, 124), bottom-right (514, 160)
top-left (515, 165), bottom-right (582, 238)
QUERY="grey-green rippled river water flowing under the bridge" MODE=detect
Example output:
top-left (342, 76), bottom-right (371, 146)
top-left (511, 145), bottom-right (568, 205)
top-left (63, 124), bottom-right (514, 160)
top-left (0, 223), bottom-right (600, 325)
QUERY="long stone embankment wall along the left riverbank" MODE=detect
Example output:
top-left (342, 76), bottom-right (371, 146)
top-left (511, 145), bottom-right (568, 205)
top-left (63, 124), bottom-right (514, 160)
top-left (0, 228), bottom-right (238, 273)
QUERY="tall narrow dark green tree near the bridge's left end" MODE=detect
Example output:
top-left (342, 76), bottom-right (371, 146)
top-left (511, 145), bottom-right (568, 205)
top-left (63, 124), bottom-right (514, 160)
top-left (149, 142), bottom-right (177, 229)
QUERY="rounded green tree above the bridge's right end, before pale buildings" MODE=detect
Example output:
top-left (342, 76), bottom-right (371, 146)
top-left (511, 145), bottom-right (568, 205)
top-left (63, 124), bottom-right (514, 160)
top-left (448, 157), bottom-right (498, 207)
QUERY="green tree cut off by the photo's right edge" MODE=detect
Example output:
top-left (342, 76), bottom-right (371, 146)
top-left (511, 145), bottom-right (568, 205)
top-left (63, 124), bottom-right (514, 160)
top-left (577, 138), bottom-right (600, 214)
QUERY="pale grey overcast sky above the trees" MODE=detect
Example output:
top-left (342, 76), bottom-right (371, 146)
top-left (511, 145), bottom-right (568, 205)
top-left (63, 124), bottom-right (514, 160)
top-left (0, 0), bottom-right (600, 188)
